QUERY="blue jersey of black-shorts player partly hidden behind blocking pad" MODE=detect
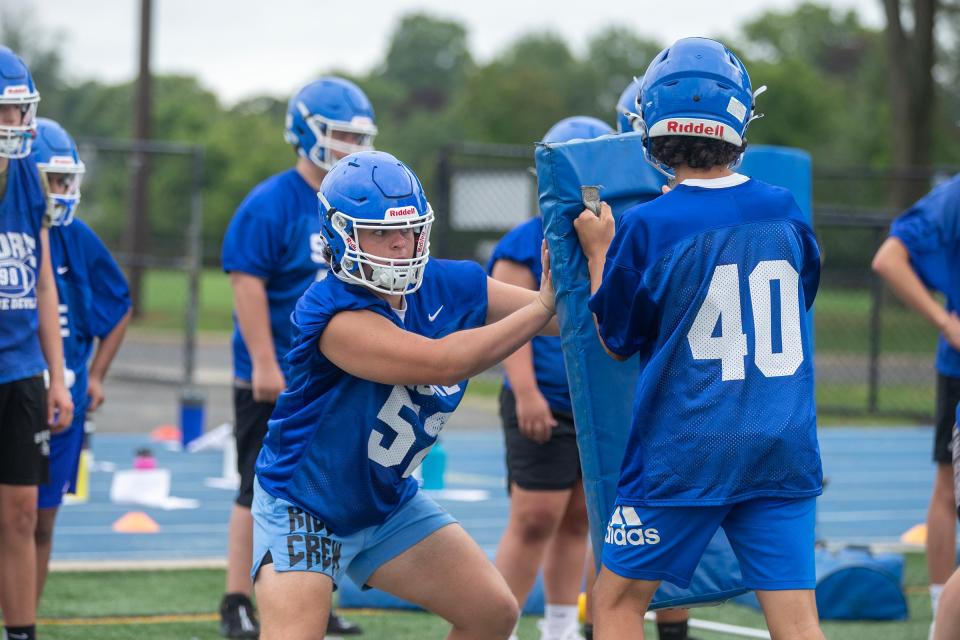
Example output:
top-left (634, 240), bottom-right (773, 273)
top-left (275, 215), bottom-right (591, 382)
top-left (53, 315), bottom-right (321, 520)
top-left (487, 216), bottom-right (573, 413)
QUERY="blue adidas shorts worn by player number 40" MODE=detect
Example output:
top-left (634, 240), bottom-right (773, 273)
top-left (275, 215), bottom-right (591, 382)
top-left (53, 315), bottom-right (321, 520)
top-left (603, 498), bottom-right (817, 591)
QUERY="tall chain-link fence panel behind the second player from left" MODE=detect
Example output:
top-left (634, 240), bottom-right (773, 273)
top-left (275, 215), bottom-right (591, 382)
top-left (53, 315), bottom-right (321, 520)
top-left (79, 139), bottom-right (205, 391)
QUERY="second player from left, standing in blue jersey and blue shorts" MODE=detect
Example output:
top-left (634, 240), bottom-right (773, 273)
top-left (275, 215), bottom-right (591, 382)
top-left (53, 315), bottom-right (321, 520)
top-left (31, 118), bottom-right (130, 600)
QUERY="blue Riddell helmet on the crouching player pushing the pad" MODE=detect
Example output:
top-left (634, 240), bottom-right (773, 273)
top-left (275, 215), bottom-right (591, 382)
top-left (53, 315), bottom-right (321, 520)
top-left (317, 151), bottom-right (433, 295)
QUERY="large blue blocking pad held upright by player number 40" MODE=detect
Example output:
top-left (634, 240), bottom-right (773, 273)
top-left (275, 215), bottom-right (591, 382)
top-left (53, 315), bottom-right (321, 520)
top-left (536, 133), bottom-right (812, 609)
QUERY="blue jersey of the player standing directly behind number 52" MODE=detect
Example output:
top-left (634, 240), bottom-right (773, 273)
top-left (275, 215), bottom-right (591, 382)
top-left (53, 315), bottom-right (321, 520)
top-left (220, 169), bottom-right (327, 381)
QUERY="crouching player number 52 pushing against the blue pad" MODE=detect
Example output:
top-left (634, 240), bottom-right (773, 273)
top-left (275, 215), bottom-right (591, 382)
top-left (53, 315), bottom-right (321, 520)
top-left (253, 151), bottom-right (556, 640)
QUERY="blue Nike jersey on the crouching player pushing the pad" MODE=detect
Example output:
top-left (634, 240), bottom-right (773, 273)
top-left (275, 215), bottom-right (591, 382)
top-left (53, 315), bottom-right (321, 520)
top-left (257, 259), bottom-right (487, 535)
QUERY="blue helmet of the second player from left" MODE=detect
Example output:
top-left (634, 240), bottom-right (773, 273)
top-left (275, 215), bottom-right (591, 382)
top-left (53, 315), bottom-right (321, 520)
top-left (30, 118), bottom-right (86, 226)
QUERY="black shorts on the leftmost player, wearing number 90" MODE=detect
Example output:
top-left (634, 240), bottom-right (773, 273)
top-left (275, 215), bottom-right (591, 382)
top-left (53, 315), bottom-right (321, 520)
top-left (0, 376), bottom-right (50, 485)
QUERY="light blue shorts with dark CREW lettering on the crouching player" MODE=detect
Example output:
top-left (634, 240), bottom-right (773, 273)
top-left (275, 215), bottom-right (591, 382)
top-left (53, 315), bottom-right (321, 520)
top-left (250, 478), bottom-right (456, 587)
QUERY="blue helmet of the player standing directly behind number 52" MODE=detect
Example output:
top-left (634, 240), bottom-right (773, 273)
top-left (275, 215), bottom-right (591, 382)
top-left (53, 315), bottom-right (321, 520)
top-left (283, 76), bottom-right (377, 171)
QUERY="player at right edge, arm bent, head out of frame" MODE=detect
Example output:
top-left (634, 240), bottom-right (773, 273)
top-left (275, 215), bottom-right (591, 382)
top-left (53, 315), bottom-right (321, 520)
top-left (873, 175), bottom-right (960, 632)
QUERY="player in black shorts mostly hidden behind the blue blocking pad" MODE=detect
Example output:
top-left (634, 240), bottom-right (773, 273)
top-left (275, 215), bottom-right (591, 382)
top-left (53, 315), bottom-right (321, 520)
top-left (487, 116), bottom-right (613, 640)
